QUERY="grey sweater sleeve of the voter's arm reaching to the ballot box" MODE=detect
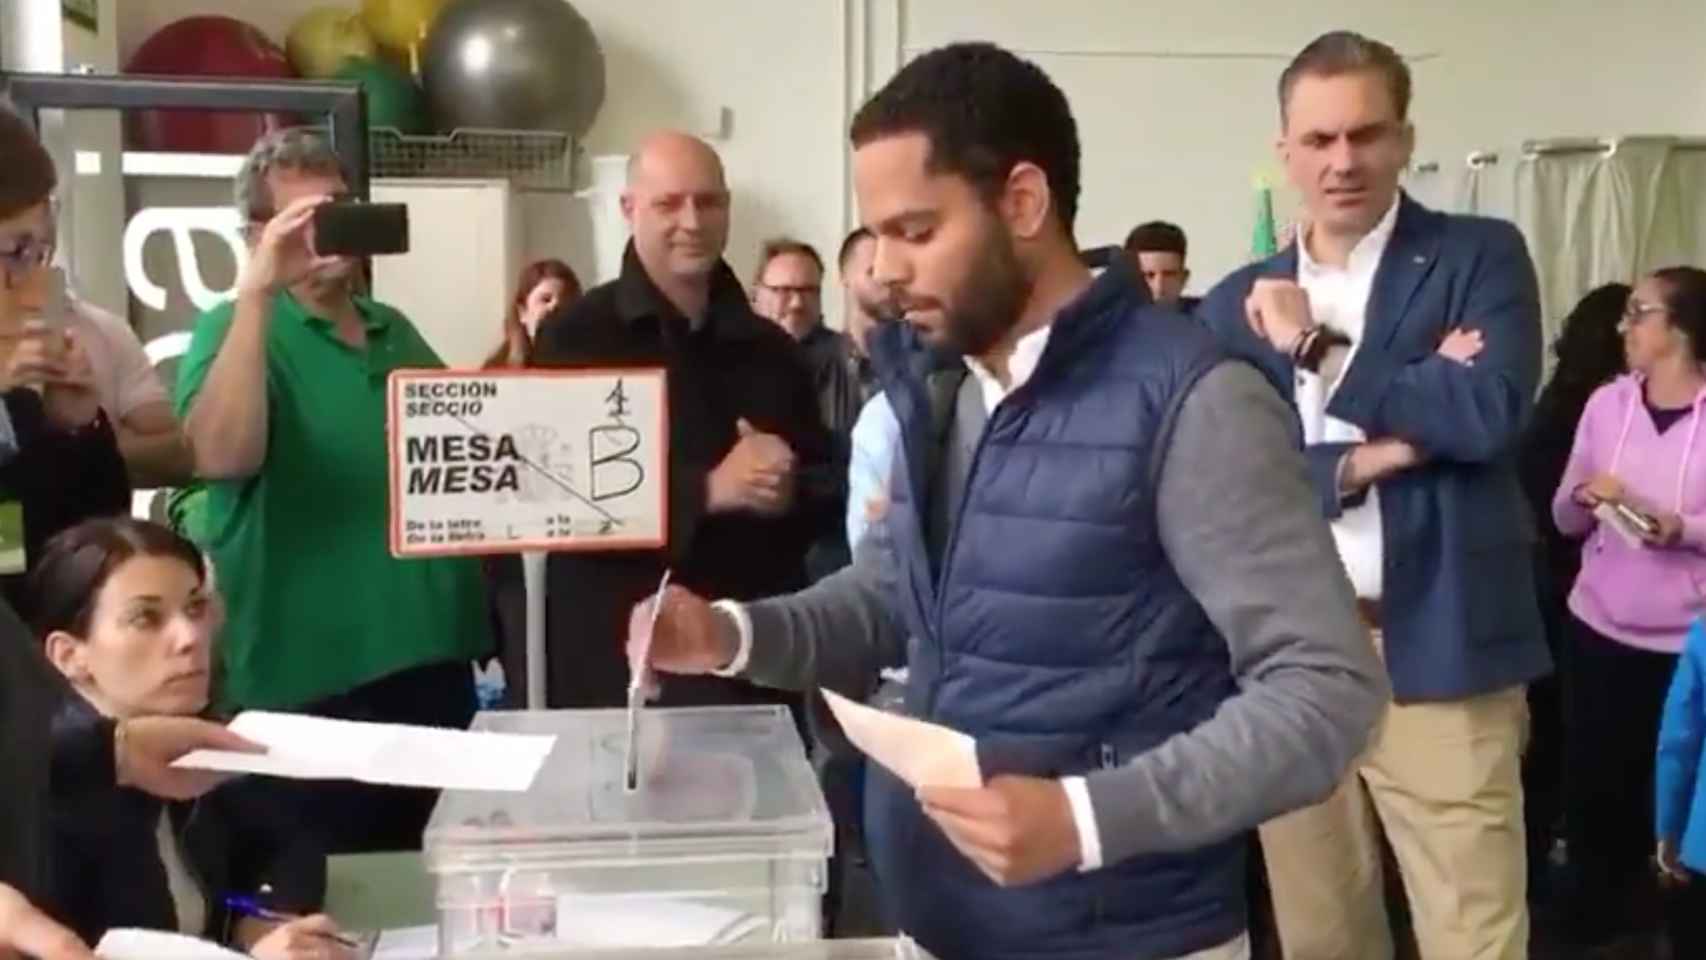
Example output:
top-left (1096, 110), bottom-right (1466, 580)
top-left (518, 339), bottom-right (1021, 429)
top-left (742, 504), bottom-right (906, 701)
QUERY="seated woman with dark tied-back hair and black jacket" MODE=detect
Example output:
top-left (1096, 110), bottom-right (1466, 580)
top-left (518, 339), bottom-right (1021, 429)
top-left (29, 517), bottom-right (353, 960)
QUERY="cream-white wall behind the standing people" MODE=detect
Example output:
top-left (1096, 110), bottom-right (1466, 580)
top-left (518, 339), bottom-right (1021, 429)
top-left (96, 0), bottom-right (1706, 300)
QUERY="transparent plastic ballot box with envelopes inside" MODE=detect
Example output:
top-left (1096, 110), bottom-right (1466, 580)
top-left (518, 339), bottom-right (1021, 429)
top-left (421, 706), bottom-right (833, 957)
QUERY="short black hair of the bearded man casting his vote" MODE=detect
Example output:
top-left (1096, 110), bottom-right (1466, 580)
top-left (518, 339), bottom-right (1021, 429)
top-left (850, 43), bottom-right (1080, 237)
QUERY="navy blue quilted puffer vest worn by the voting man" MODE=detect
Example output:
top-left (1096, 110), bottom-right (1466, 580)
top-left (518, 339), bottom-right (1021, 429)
top-left (868, 266), bottom-right (1245, 960)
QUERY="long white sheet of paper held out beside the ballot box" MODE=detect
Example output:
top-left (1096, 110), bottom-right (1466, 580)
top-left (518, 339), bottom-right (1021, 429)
top-left (172, 709), bottom-right (556, 793)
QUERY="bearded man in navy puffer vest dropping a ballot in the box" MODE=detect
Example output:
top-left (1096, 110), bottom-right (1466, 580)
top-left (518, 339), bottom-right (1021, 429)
top-left (633, 44), bottom-right (1387, 960)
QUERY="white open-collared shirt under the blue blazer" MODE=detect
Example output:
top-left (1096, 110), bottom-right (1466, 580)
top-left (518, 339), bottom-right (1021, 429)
top-left (1297, 200), bottom-right (1397, 600)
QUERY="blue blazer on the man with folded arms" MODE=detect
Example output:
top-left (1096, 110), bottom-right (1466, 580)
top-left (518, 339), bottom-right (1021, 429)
top-left (1196, 196), bottom-right (1551, 703)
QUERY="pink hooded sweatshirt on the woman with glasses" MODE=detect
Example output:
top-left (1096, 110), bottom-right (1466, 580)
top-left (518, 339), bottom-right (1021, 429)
top-left (1552, 373), bottom-right (1706, 653)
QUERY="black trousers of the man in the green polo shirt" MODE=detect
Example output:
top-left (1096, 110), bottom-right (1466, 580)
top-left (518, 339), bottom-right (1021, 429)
top-left (255, 660), bottom-right (474, 854)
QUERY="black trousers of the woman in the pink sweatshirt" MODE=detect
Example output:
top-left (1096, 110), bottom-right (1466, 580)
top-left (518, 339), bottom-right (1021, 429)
top-left (1564, 617), bottom-right (1677, 945)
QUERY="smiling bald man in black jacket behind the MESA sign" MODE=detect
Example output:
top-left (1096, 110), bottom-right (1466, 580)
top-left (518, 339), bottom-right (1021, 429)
top-left (534, 133), bottom-right (841, 708)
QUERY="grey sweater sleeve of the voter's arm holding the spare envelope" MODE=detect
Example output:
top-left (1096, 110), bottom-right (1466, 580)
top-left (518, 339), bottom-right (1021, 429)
top-left (1087, 361), bottom-right (1389, 865)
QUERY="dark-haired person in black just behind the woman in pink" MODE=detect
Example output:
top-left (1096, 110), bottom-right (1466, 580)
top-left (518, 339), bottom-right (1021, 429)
top-left (1517, 283), bottom-right (1629, 897)
